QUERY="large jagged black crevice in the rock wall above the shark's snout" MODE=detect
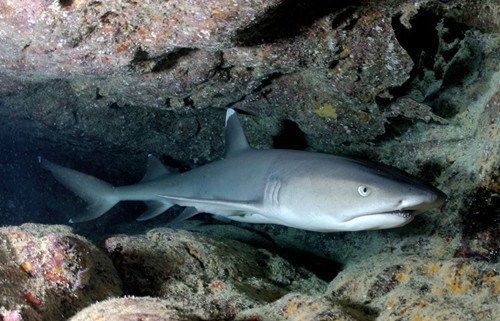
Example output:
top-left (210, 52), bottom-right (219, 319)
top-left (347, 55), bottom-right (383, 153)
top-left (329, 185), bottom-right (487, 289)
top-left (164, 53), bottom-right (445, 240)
top-left (375, 10), bottom-right (481, 142)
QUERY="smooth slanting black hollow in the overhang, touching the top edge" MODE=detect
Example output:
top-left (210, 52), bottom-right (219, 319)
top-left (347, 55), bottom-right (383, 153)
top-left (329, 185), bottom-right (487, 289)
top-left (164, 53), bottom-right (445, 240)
top-left (234, 0), bottom-right (359, 46)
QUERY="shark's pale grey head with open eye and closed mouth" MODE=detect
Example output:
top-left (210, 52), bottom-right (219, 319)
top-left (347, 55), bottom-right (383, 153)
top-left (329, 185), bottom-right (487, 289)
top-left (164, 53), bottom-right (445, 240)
top-left (283, 157), bottom-right (446, 231)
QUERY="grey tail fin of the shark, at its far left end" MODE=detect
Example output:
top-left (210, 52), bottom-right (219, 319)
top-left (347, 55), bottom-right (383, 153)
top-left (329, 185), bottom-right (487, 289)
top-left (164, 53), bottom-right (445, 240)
top-left (38, 157), bottom-right (120, 223)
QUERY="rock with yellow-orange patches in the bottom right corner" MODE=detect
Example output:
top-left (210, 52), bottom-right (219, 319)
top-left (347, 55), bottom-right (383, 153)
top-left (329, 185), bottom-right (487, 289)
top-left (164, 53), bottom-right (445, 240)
top-left (327, 255), bottom-right (500, 321)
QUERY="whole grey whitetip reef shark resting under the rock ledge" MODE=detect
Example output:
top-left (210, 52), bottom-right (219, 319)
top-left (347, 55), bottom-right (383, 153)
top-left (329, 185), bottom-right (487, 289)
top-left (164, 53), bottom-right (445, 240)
top-left (39, 109), bottom-right (446, 232)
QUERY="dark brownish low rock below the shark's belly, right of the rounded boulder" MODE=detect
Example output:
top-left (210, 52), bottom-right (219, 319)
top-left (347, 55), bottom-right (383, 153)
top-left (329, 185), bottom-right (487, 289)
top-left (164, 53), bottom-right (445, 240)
top-left (105, 228), bottom-right (325, 319)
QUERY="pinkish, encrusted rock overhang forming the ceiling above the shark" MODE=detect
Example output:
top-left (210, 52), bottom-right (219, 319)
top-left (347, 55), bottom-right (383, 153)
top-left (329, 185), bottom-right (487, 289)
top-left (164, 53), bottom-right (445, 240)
top-left (0, 0), bottom-right (494, 163)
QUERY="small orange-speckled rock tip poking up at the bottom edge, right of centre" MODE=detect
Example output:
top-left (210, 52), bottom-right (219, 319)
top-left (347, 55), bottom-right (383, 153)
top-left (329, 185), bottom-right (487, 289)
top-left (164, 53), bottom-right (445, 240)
top-left (235, 293), bottom-right (366, 321)
